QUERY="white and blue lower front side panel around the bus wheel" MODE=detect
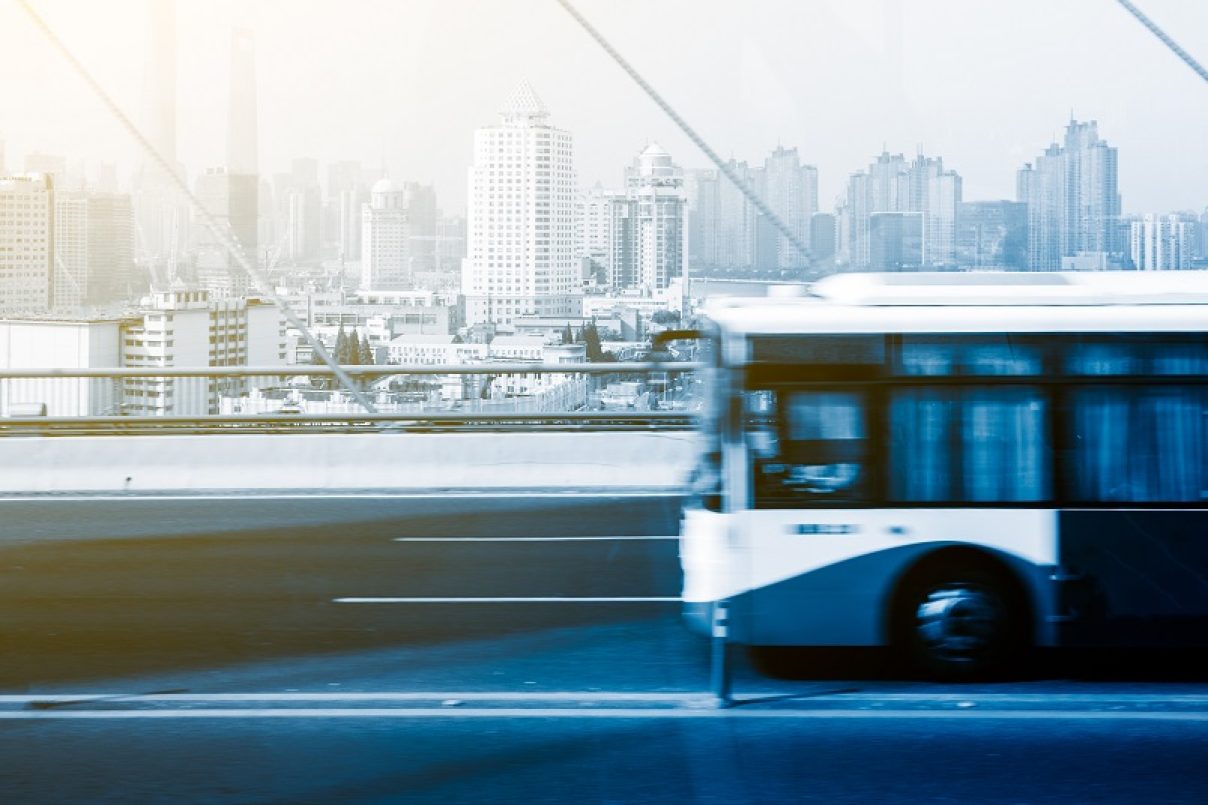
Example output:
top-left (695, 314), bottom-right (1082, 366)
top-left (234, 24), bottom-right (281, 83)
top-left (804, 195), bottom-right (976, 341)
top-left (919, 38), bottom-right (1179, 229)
top-left (681, 509), bottom-right (1057, 647)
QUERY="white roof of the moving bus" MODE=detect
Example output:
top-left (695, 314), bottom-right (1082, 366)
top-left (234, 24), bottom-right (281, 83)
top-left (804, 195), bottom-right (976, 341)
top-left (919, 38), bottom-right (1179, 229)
top-left (704, 271), bottom-right (1208, 335)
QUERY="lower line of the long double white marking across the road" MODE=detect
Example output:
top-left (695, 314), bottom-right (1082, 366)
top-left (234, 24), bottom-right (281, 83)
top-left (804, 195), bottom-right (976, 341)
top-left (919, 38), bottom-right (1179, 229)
top-left (0, 707), bottom-right (1208, 723)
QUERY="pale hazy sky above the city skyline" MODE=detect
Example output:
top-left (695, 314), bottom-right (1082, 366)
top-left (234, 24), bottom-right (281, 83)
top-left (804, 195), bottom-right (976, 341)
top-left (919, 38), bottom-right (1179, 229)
top-left (0, 0), bottom-right (1208, 212)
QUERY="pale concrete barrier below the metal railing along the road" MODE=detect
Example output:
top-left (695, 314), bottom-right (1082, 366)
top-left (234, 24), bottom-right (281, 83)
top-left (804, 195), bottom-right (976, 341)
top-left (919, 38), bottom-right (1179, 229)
top-left (0, 432), bottom-right (698, 494)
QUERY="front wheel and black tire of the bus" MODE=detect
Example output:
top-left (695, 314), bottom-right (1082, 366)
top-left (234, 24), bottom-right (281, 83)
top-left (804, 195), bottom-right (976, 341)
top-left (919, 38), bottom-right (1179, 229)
top-left (892, 554), bottom-right (1028, 682)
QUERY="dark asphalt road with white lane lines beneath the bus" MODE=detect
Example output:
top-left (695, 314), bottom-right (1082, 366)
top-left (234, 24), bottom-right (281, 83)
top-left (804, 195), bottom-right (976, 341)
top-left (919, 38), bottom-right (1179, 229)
top-left (0, 496), bottom-right (1208, 803)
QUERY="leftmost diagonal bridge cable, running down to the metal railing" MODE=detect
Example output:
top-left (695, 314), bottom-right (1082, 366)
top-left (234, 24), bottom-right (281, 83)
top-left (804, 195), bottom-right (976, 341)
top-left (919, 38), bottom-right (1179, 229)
top-left (17, 0), bottom-right (374, 413)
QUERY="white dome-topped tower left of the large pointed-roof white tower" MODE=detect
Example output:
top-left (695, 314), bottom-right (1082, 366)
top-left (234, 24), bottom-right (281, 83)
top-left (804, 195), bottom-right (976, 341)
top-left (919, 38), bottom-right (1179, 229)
top-left (360, 176), bottom-right (411, 290)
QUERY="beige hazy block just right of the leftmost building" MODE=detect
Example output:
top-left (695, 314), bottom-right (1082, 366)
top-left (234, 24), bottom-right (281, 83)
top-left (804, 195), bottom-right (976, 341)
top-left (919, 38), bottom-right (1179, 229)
top-left (52, 192), bottom-right (135, 311)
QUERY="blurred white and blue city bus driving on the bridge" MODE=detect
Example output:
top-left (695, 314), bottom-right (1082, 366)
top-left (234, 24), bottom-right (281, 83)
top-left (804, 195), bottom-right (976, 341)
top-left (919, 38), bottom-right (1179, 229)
top-left (680, 271), bottom-right (1208, 678)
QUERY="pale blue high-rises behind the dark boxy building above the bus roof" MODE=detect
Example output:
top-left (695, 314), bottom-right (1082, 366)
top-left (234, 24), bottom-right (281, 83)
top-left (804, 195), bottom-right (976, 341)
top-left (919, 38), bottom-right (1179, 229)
top-left (847, 147), bottom-right (962, 267)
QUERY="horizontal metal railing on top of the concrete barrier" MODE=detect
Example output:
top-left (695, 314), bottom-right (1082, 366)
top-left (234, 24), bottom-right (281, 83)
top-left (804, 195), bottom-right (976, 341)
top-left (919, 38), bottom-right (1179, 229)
top-left (0, 360), bottom-right (701, 436)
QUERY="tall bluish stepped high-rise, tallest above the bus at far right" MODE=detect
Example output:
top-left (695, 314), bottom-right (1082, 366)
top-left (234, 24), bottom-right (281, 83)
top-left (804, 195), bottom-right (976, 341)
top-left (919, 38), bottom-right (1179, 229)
top-left (1016, 121), bottom-right (1122, 271)
